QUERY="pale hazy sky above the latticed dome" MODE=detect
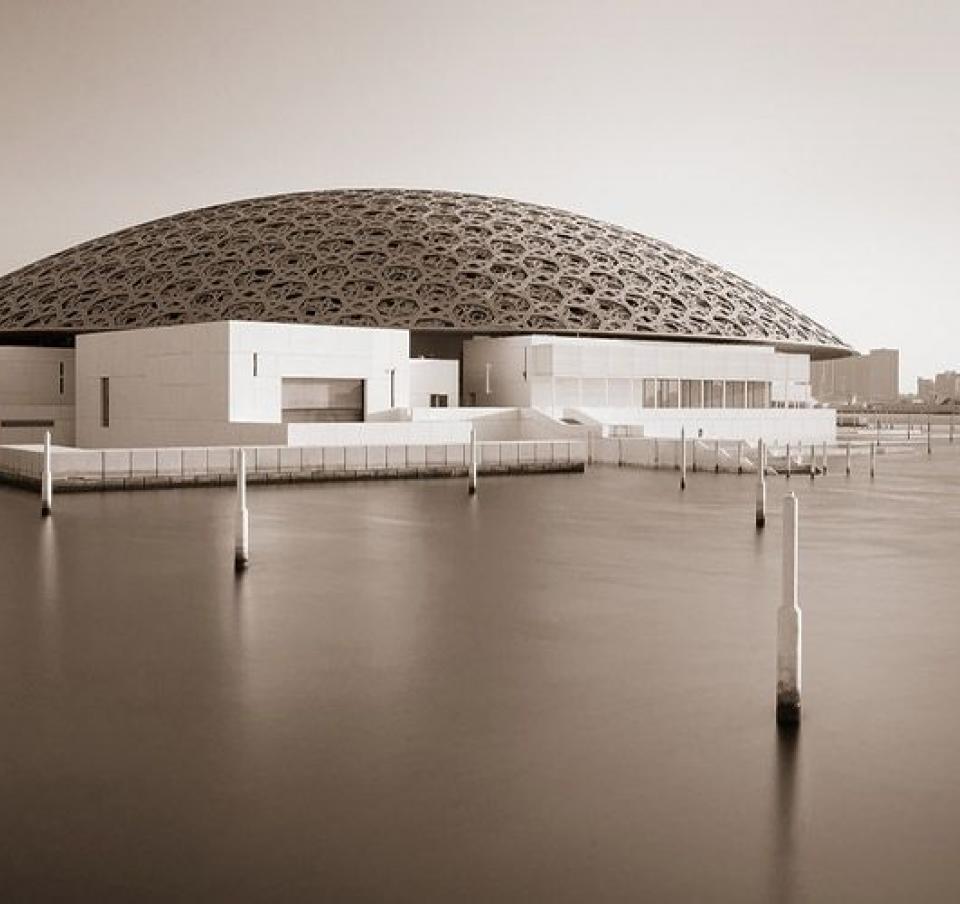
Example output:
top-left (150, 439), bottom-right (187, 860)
top-left (0, 0), bottom-right (960, 388)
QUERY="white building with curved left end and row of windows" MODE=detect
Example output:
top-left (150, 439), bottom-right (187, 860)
top-left (463, 335), bottom-right (836, 442)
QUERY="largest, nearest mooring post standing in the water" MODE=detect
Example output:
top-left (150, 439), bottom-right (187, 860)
top-left (777, 493), bottom-right (802, 725)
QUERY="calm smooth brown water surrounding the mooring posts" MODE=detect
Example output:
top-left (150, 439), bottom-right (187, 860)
top-left (0, 446), bottom-right (960, 902)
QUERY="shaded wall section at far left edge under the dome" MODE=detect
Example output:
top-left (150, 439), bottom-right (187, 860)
top-left (0, 346), bottom-right (75, 445)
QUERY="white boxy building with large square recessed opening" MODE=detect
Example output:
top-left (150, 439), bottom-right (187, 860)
top-left (77, 321), bottom-right (458, 447)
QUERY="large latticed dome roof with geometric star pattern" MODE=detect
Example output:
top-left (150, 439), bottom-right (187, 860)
top-left (0, 189), bottom-right (849, 356)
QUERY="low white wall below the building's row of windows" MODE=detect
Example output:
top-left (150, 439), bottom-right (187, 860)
top-left (565, 408), bottom-right (837, 443)
